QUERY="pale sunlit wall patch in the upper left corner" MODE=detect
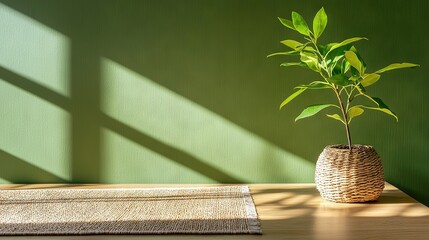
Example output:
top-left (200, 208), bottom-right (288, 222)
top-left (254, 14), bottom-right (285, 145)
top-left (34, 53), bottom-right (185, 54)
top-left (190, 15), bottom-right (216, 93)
top-left (0, 3), bottom-right (70, 96)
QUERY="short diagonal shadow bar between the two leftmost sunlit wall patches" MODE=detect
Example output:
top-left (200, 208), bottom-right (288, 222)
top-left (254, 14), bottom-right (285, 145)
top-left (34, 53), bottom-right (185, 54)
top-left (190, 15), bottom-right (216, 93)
top-left (0, 66), bottom-right (71, 112)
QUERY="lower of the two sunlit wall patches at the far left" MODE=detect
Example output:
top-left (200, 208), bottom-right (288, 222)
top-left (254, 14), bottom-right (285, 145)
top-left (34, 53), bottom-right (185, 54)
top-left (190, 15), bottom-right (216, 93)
top-left (0, 78), bottom-right (70, 182)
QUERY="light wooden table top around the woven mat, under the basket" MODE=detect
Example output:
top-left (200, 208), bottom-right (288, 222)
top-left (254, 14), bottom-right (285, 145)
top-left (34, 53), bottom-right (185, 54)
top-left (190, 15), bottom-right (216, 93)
top-left (0, 184), bottom-right (429, 240)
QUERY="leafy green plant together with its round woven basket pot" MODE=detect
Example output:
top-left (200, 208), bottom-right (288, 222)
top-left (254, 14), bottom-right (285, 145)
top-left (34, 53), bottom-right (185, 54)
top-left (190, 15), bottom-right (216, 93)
top-left (268, 7), bottom-right (418, 202)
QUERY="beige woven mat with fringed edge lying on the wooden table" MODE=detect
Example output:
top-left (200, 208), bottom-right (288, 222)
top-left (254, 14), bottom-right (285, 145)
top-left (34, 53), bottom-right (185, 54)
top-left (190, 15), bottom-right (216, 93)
top-left (0, 186), bottom-right (261, 235)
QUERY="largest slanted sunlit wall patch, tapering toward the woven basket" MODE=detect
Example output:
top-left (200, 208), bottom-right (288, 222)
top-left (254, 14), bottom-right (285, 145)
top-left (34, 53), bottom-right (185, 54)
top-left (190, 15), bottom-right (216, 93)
top-left (101, 58), bottom-right (314, 182)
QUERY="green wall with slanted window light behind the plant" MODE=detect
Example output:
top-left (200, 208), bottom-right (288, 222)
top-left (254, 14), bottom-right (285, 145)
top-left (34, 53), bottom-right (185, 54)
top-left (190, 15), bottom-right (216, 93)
top-left (0, 0), bottom-right (429, 204)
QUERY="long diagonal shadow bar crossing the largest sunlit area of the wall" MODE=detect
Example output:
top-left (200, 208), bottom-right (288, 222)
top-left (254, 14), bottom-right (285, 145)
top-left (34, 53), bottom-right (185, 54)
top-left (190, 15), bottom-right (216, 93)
top-left (100, 113), bottom-right (243, 183)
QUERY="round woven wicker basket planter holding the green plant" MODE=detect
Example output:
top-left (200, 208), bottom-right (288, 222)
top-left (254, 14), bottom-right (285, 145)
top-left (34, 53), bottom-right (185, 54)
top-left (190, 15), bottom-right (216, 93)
top-left (316, 145), bottom-right (384, 203)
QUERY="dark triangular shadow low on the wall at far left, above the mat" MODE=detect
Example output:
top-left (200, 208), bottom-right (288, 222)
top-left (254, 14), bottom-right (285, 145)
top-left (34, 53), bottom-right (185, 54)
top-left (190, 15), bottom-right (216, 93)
top-left (0, 149), bottom-right (68, 183)
